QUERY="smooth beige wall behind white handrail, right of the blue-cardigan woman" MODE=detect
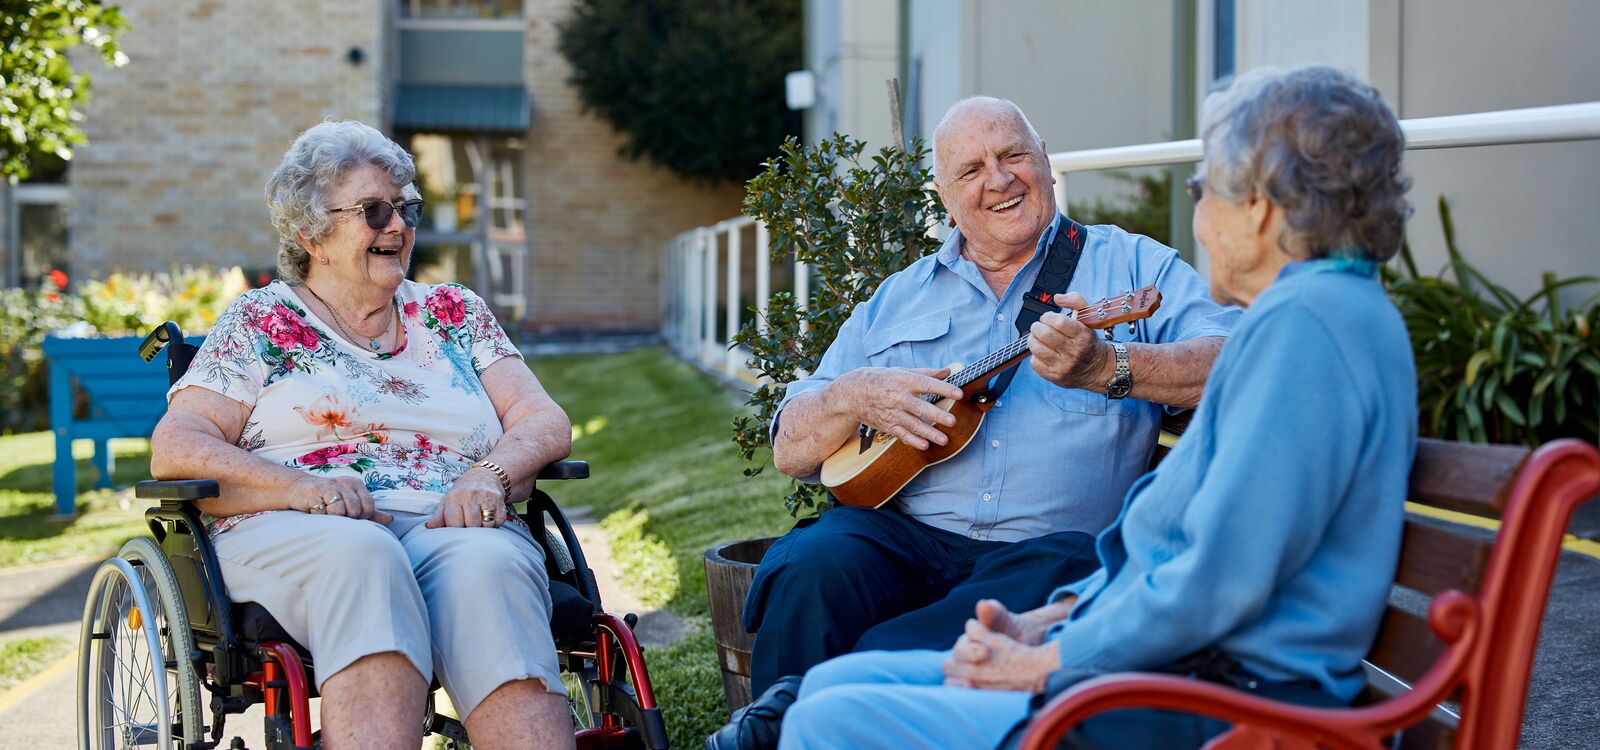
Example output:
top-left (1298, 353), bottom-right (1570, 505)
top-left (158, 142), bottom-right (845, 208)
top-left (1374, 0), bottom-right (1600, 301)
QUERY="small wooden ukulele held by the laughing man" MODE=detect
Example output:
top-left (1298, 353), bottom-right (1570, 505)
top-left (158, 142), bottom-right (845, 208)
top-left (822, 286), bottom-right (1162, 509)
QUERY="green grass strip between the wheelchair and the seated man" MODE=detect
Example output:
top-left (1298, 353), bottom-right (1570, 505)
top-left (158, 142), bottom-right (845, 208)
top-left (531, 349), bottom-right (806, 748)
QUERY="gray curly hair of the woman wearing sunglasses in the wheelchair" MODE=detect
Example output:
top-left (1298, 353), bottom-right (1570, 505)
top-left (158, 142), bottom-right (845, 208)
top-left (267, 120), bottom-right (421, 283)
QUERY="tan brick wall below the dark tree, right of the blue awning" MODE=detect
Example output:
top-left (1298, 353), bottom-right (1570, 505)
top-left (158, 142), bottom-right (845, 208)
top-left (523, 0), bottom-right (744, 331)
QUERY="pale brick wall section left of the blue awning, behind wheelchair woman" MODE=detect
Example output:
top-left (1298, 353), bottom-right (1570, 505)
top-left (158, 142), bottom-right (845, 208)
top-left (69, 0), bottom-right (394, 278)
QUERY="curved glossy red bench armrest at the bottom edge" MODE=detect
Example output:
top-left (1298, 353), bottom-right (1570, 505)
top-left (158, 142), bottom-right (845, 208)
top-left (1021, 672), bottom-right (1382, 750)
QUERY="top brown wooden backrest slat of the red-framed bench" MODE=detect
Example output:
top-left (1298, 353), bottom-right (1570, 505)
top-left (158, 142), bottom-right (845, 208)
top-left (1410, 438), bottom-right (1533, 518)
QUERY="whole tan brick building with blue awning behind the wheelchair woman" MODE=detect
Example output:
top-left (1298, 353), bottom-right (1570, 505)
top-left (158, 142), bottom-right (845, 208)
top-left (0, 0), bottom-right (742, 333)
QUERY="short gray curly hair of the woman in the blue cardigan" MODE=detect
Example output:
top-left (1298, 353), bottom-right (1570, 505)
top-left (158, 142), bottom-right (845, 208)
top-left (1200, 66), bottom-right (1411, 262)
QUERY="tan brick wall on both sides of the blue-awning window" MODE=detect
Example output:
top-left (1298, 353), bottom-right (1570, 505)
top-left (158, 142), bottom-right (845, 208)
top-left (69, 0), bottom-right (742, 331)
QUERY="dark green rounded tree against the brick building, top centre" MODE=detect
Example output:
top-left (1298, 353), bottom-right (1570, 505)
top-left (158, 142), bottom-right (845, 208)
top-left (560, 0), bottom-right (803, 181)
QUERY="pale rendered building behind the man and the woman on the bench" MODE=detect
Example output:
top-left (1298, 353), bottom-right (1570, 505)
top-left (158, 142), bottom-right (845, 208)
top-left (806, 0), bottom-right (1600, 296)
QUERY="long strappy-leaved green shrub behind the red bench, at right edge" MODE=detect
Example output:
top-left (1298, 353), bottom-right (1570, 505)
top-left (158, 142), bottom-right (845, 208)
top-left (1384, 195), bottom-right (1600, 445)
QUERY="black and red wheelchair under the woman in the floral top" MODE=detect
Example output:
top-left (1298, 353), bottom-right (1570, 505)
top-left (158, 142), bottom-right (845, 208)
top-left (77, 321), bottom-right (667, 750)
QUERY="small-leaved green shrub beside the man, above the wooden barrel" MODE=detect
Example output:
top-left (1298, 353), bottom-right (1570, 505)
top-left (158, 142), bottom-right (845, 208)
top-left (733, 133), bottom-right (944, 513)
